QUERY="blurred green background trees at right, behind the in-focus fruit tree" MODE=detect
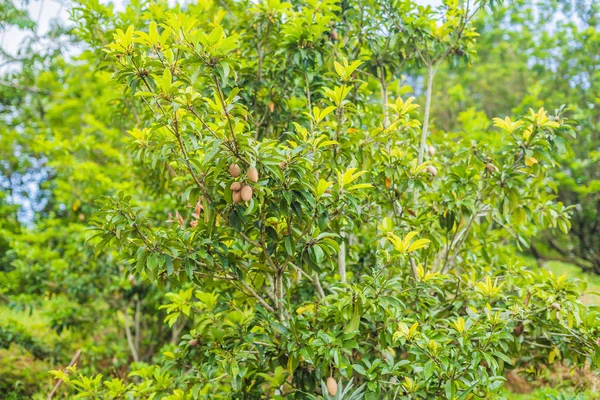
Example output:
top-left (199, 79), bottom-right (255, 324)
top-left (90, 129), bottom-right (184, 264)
top-left (433, 0), bottom-right (600, 274)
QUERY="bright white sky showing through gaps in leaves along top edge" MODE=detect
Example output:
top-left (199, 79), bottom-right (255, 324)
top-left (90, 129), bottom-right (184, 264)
top-left (0, 0), bottom-right (442, 55)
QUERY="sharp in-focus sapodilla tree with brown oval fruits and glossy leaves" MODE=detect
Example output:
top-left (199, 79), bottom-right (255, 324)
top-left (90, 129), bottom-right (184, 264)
top-left (55, 1), bottom-right (598, 399)
